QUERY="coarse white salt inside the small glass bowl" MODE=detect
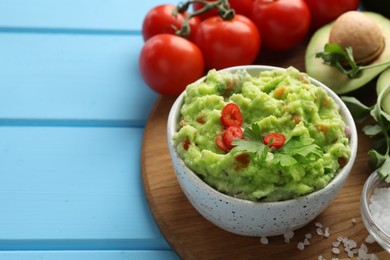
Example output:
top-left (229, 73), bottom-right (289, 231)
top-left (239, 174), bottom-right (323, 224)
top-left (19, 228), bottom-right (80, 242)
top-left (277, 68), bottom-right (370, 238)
top-left (369, 188), bottom-right (390, 234)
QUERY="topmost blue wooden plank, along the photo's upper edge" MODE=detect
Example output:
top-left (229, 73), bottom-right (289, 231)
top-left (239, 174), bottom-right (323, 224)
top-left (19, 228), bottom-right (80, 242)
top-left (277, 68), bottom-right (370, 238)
top-left (0, 0), bottom-right (180, 33)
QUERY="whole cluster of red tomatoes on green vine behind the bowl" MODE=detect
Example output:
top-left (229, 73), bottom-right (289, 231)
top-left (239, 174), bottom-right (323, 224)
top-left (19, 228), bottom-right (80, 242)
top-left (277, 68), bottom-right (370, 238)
top-left (139, 0), bottom-right (359, 96)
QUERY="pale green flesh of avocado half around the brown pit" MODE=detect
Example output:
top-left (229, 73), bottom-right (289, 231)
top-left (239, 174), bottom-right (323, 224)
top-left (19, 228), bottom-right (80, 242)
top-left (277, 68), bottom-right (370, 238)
top-left (305, 12), bottom-right (390, 94)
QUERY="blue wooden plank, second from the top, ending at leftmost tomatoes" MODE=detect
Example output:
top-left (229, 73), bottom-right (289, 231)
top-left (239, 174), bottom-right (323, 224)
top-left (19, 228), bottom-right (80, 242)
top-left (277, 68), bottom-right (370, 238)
top-left (0, 33), bottom-right (157, 126)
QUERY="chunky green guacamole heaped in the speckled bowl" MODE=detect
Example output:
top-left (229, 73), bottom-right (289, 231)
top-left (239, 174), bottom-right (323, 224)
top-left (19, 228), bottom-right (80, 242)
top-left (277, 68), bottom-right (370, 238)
top-left (174, 67), bottom-right (351, 201)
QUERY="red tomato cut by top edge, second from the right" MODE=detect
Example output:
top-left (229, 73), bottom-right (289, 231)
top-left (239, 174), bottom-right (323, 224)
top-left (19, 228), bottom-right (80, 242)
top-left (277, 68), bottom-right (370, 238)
top-left (252, 0), bottom-right (310, 51)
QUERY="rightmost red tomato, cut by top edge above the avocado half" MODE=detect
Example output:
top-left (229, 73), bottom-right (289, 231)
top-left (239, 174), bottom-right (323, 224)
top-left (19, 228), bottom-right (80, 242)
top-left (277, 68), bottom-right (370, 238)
top-left (305, 0), bottom-right (360, 29)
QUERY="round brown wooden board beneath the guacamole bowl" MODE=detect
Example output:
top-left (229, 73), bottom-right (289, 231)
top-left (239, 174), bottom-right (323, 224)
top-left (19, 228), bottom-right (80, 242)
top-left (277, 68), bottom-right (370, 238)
top-left (142, 48), bottom-right (390, 259)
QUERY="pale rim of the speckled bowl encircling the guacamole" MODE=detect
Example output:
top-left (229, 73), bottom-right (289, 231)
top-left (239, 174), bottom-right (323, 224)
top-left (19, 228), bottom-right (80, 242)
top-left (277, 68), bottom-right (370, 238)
top-left (167, 65), bottom-right (358, 207)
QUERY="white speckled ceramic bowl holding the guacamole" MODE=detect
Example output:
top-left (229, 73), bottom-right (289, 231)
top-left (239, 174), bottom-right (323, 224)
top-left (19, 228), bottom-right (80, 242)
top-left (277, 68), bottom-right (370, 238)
top-left (167, 65), bottom-right (358, 237)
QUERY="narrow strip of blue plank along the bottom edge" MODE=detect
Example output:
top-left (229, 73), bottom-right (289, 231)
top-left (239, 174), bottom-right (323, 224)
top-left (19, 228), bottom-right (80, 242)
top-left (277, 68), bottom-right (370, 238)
top-left (0, 250), bottom-right (179, 260)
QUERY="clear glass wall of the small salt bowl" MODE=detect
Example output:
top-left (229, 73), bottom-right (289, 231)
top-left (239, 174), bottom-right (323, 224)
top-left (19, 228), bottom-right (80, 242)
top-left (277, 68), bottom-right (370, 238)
top-left (360, 171), bottom-right (390, 253)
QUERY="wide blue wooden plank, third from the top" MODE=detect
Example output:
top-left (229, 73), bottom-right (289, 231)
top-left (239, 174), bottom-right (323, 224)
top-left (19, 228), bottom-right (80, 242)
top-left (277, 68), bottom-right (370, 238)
top-left (0, 127), bottom-right (169, 250)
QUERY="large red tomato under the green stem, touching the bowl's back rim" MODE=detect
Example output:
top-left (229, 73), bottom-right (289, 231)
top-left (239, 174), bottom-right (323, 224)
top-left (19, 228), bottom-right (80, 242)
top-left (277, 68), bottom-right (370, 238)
top-left (194, 14), bottom-right (261, 69)
